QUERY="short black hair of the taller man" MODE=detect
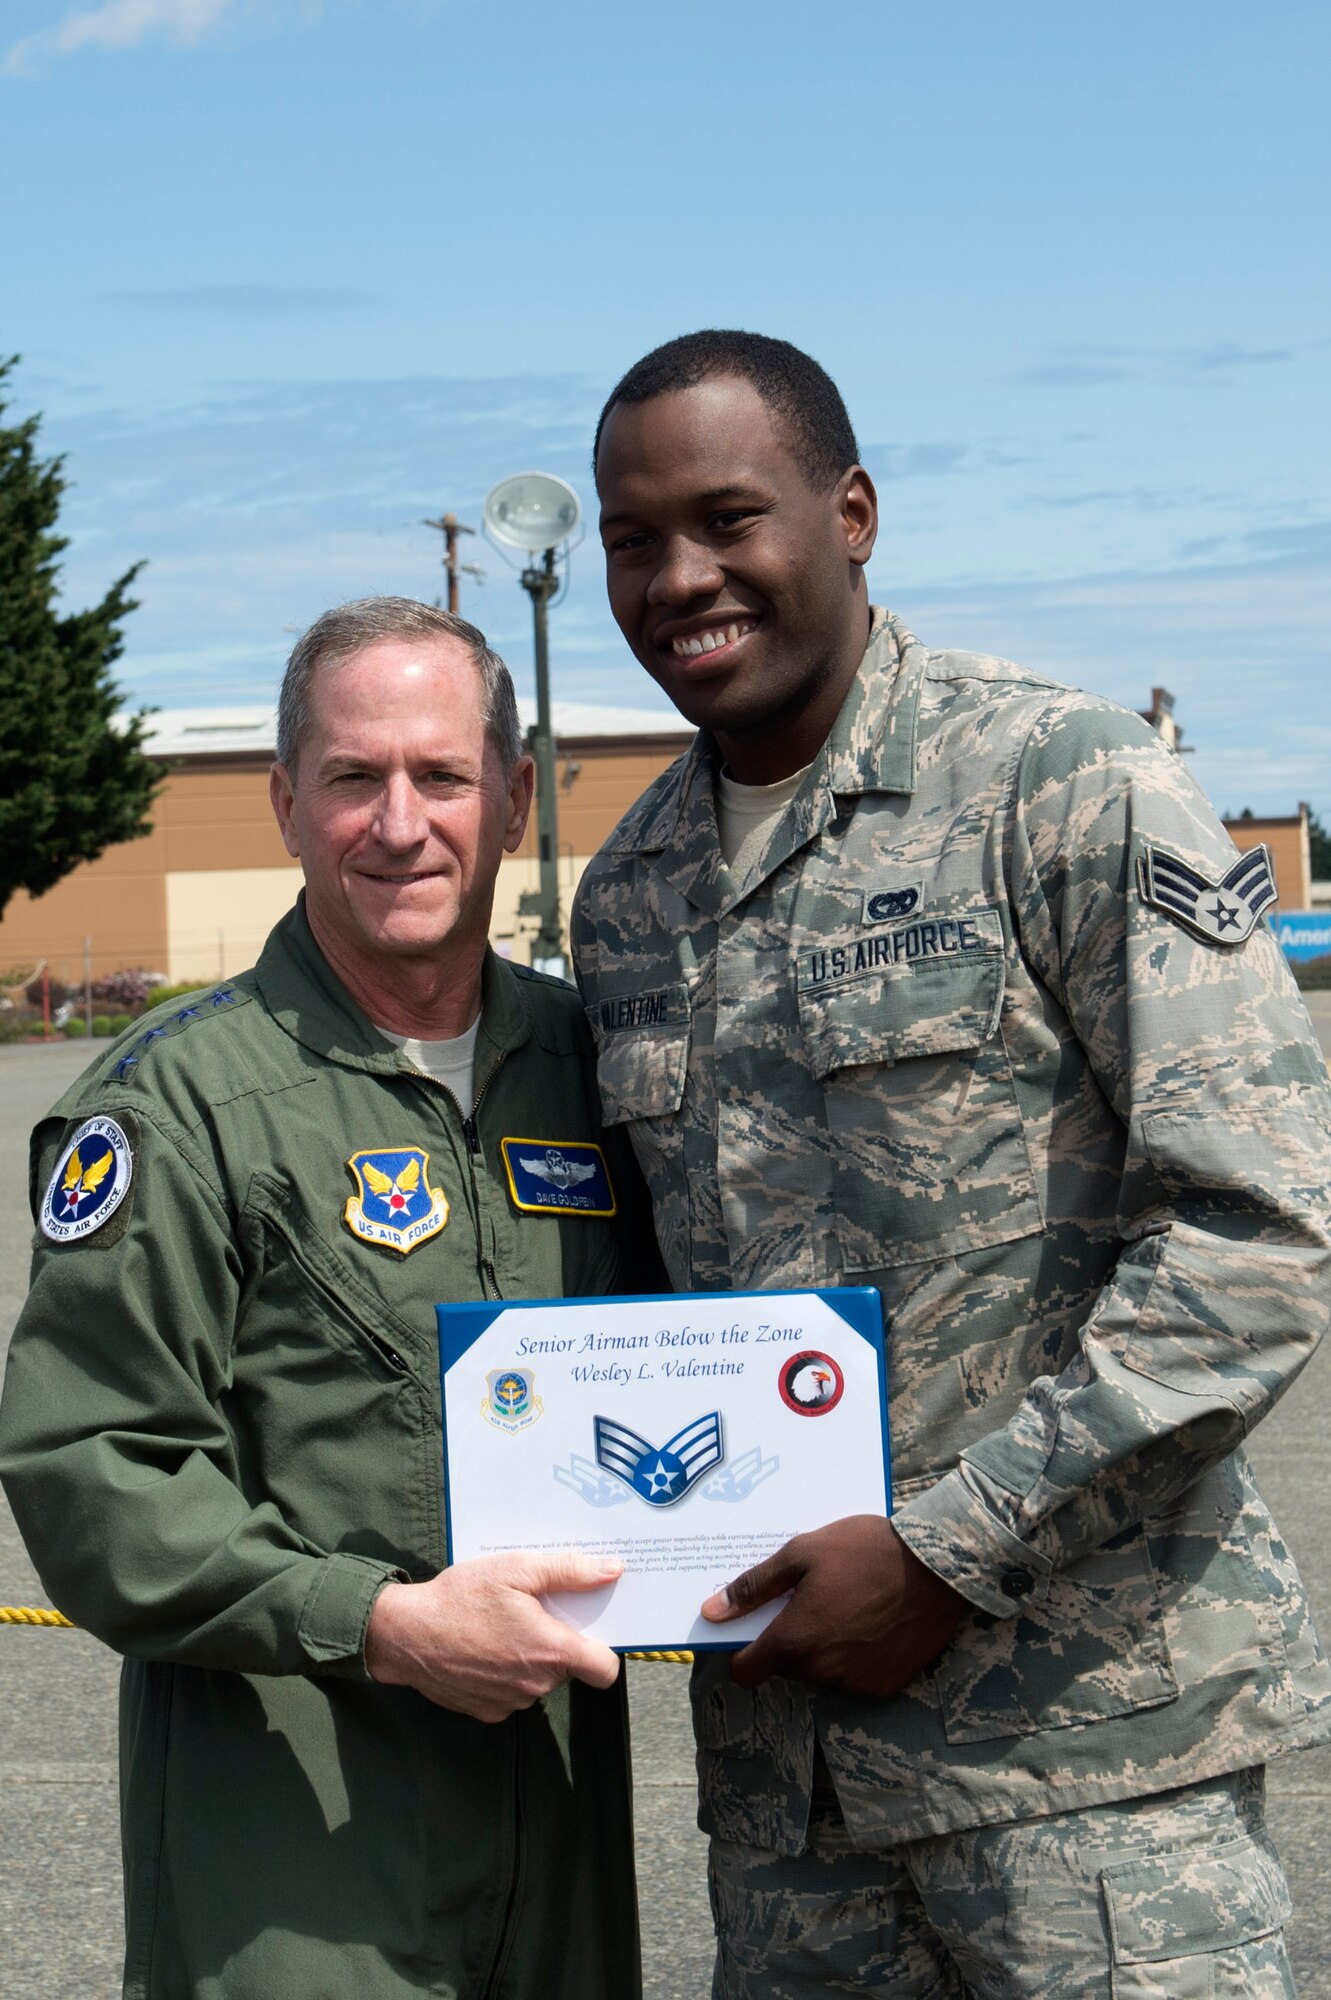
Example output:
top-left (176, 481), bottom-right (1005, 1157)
top-left (592, 326), bottom-right (859, 492)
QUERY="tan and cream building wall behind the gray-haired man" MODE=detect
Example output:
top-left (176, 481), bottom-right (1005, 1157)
top-left (0, 734), bottom-right (687, 984)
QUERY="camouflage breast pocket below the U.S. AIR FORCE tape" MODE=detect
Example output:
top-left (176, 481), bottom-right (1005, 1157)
top-left (799, 936), bottom-right (1041, 1274)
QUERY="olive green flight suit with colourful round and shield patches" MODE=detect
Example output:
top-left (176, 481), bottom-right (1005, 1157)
top-left (0, 908), bottom-right (658, 2000)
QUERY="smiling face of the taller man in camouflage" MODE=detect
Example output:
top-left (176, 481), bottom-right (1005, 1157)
top-left (598, 376), bottom-right (877, 784)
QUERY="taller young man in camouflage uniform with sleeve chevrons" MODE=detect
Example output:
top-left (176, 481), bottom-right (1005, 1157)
top-left (576, 334), bottom-right (1331, 2000)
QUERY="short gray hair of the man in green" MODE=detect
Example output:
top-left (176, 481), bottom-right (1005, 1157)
top-left (278, 598), bottom-right (522, 778)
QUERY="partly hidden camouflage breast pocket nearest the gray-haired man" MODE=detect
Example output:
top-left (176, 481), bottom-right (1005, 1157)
top-left (588, 984), bottom-right (689, 1272)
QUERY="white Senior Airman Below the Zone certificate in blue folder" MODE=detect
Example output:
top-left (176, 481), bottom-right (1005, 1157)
top-left (438, 1286), bottom-right (891, 1652)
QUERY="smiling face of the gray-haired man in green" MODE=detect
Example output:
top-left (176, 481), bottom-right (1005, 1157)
top-left (272, 638), bottom-right (532, 992)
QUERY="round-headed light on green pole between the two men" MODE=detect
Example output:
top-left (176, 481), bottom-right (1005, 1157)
top-left (484, 472), bottom-right (582, 978)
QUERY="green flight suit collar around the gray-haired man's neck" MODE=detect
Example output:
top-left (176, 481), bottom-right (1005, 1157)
top-left (254, 890), bottom-right (532, 1076)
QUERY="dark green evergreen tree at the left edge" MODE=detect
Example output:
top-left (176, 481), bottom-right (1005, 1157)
top-left (0, 360), bottom-right (166, 912)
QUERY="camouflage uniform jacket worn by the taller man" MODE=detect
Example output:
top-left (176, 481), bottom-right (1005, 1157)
top-left (574, 612), bottom-right (1331, 1852)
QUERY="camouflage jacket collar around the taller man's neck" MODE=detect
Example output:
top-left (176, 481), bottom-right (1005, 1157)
top-left (614, 606), bottom-right (927, 916)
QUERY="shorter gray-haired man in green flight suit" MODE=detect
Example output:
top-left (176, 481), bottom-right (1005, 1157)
top-left (0, 598), bottom-right (658, 2000)
